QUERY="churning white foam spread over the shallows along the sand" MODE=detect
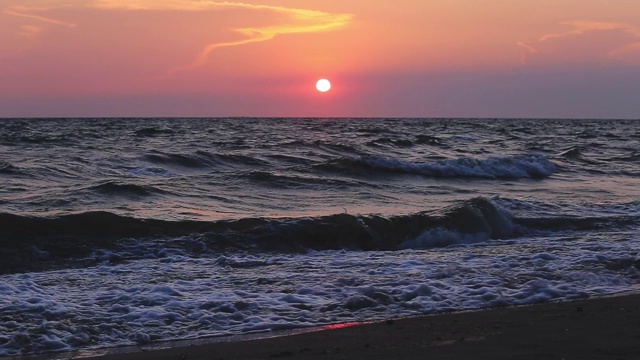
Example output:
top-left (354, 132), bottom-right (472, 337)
top-left (0, 230), bottom-right (640, 356)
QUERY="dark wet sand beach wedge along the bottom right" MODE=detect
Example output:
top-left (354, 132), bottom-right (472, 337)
top-left (32, 294), bottom-right (640, 360)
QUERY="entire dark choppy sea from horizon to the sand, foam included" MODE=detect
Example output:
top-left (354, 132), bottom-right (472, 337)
top-left (0, 118), bottom-right (640, 356)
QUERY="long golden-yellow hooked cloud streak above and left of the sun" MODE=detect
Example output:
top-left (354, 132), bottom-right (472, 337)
top-left (3, 0), bottom-right (353, 70)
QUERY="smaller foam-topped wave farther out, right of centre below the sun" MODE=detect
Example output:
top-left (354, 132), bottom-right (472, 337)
top-left (321, 154), bottom-right (556, 179)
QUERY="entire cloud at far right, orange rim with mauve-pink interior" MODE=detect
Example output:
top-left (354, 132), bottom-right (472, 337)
top-left (516, 21), bottom-right (640, 64)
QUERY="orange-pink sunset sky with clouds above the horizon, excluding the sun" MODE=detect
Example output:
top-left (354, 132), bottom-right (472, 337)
top-left (0, 0), bottom-right (640, 118)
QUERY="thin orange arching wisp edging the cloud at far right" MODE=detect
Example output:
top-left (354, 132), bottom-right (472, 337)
top-left (516, 21), bottom-right (640, 64)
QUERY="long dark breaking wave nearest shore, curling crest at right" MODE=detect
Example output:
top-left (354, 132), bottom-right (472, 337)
top-left (0, 198), bottom-right (640, 273)
